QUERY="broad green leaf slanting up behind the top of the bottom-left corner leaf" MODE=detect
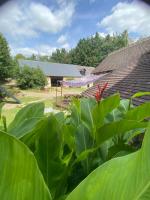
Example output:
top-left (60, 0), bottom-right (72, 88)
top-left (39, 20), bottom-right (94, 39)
top-left (8, 103), bottom-right (44, 138)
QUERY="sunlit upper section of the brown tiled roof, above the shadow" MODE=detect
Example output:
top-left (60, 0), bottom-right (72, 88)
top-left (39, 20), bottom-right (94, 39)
top-left (92, 38), bottom-right (150, 74)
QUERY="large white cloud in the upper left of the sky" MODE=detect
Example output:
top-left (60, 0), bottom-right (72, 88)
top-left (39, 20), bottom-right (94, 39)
top-left (0, 0), bottom-right (75, 37)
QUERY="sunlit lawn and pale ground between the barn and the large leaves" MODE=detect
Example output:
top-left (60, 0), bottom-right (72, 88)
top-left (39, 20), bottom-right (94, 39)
top-left (2, 85), bottom-right (84, 125)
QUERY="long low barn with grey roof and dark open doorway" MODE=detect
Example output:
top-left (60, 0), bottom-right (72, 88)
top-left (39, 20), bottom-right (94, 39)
top-left (19, 60), bottom-right (93, 87)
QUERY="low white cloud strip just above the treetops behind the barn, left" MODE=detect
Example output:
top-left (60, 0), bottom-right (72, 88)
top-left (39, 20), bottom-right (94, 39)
top-left (11, 45), bottom-right (56, 56)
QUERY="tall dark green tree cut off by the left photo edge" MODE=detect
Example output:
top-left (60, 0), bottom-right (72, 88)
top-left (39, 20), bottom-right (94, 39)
top-left (0, 33), bottom-right (12, 81)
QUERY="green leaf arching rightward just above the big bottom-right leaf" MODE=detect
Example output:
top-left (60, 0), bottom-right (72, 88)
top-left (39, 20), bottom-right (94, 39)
top-left (96, 119), bottom-right (147, 145)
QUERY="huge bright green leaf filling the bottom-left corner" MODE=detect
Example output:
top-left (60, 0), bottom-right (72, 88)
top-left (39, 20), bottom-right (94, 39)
top-left (0, 132), bottom-right (51, 200)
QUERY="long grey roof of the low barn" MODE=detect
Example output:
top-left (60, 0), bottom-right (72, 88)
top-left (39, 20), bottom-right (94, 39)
top-left (18, 59), bottom-right (81, 77)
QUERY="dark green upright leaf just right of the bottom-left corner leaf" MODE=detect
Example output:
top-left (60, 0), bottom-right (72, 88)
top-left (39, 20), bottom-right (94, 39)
top-left (35, 115), bottom-right (68, 199)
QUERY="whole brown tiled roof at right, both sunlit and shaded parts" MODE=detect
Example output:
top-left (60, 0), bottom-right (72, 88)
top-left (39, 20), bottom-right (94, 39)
top-left (82, 38), bottom-right (150, 105)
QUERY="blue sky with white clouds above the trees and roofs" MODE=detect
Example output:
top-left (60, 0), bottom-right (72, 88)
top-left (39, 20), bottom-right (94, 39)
top-left (0, 0), bottom-right (150, 56)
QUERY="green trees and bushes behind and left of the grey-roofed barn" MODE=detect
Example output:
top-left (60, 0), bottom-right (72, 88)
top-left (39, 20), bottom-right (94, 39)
top-left (0, 31), bottom-right (129, 88)
